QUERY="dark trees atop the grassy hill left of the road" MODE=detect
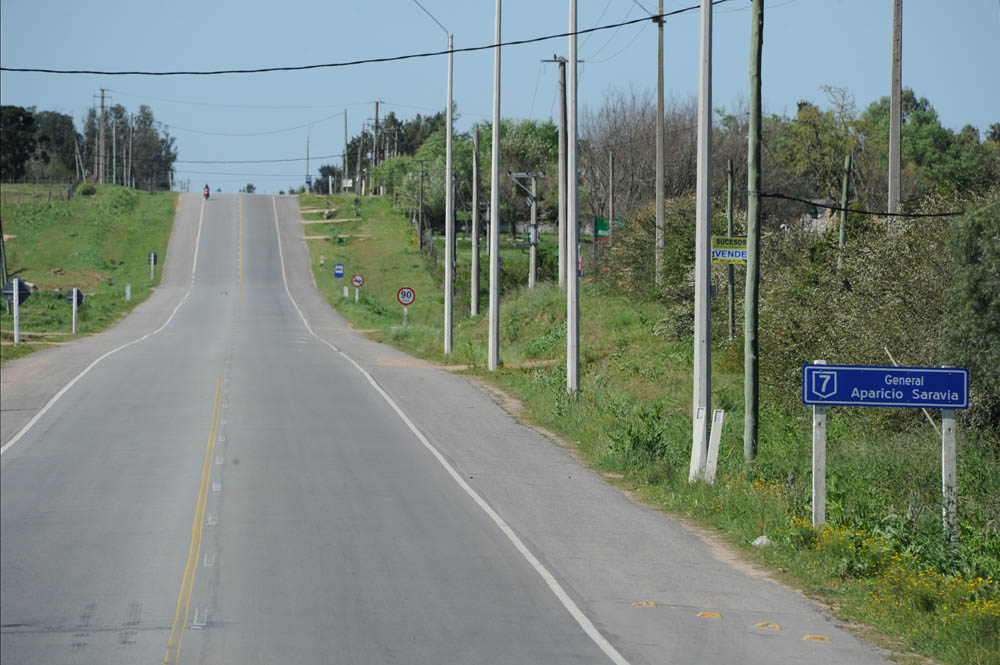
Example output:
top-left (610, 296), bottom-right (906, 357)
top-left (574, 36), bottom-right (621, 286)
top-left (0, 104), bottom-right (177, 190)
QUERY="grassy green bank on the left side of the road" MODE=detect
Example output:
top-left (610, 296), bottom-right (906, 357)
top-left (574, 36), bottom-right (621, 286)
top-left (0, 185), bottom-right (177, 363)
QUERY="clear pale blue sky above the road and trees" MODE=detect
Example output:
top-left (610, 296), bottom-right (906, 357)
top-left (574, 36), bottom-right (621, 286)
top-left (0, 0), bottom-right (1000, 193)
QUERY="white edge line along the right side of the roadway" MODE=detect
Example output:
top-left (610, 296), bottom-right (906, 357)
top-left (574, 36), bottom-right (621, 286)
top-left (271, 197), bottom-right (630, 665)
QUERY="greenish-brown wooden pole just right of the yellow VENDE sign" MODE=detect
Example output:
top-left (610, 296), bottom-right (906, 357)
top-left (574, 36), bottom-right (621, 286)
top-left (743, 0), bottom-right (764, 462)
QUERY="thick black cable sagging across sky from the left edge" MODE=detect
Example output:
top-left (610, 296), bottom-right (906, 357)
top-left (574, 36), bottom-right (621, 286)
top-left (0, 0), bottom-right (729, 76)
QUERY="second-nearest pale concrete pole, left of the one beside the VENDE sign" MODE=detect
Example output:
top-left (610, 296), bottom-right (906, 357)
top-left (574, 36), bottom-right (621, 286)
top-left (566, 0), bottom-right (580, 397)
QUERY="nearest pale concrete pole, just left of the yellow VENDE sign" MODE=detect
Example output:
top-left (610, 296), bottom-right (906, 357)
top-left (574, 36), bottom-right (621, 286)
top-left (692, 0), bottom-right (712, 474)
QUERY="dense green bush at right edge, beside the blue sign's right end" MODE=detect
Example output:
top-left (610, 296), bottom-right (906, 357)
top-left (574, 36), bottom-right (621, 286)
top-left (944, 195), bottom-right (1000, 429)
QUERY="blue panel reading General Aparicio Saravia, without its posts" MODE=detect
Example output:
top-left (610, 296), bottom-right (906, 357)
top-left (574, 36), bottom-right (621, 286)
top-left (802, 365), bottom-right (969, 409)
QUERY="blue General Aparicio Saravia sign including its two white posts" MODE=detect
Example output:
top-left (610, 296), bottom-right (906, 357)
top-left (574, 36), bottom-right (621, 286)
top-left (802, 360), bottom-right (969, 540)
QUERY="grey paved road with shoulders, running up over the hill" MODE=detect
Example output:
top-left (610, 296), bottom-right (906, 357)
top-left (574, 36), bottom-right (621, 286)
top-left (0, 196), bottom-right (885, 665)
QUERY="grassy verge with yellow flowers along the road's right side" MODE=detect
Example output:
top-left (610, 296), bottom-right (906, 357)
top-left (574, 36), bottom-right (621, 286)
top-left (300, 196), bottom-right (1000, 665)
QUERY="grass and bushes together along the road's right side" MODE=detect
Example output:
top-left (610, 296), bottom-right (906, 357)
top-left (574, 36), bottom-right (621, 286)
top-left (300, 184), bottom-right (1000, 665)
